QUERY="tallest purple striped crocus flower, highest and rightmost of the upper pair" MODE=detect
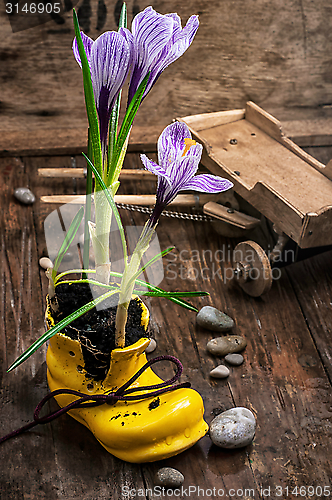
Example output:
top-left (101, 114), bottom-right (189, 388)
top-left (120, 7), bottom-right (199, 103)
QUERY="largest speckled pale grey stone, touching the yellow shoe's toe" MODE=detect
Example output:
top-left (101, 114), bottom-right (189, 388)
top-left (210, 406), bottom-right (256, 448)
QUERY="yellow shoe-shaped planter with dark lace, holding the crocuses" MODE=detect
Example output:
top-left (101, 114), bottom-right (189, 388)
top-left (46, 294), bottom-right (208, 462)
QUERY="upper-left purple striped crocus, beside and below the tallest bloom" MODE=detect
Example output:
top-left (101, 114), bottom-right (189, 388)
top-left (73, 31), bottom-right (132, 155)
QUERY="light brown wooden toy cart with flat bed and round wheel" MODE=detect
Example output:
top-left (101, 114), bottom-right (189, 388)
top-left (179, 102), bottom-right (332, 296)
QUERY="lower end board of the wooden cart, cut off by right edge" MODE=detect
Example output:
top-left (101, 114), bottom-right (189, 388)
top-left (299, 206), bottom-right (332, 248)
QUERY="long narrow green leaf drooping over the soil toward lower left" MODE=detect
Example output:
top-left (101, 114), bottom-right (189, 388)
top-left (7, 290), bottom-right (117, 373)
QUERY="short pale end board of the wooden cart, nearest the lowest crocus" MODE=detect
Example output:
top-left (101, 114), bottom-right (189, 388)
top-left (177, 109), bottom-right (245, 132)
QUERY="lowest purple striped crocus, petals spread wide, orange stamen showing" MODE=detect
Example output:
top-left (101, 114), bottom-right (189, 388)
top-left (141, 122), bottom-right (233, 226)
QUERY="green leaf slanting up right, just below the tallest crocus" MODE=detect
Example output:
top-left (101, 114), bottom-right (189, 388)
top-left (109, 73), bottom-right (150, 183)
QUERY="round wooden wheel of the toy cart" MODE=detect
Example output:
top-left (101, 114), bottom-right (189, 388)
top-left (233, 241), bottom-right (272, 297)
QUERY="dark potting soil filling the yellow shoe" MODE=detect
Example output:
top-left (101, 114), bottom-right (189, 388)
top-left (51, 283), bottom-right (149, 380)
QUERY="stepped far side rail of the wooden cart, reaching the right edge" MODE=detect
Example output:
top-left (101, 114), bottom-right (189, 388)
top-left (245, 101), bottom-right (332, 180)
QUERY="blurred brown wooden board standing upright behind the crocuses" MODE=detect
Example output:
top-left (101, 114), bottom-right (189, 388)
top-left (0, 0), bottom-right (332, 150)
